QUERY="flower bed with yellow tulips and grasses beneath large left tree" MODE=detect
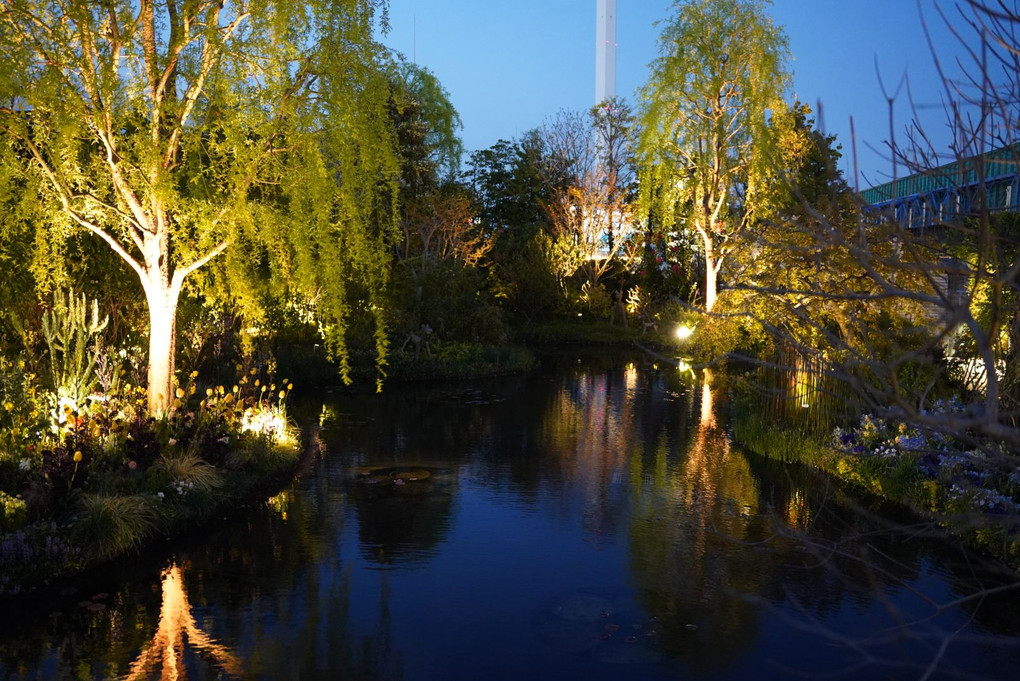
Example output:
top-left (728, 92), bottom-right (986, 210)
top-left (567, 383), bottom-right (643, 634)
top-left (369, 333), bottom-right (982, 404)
top-left (0, 359), bottom-right (299, 594)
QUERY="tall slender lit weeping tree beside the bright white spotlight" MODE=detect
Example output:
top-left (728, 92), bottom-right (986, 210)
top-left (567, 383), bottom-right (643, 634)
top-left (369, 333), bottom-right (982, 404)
top-left (639, 0), bottom-right (789, 311)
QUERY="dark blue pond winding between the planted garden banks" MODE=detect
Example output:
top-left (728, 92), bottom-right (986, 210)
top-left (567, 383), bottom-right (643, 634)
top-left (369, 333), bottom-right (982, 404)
top-left (0, 356), bottom-right (1020, 681)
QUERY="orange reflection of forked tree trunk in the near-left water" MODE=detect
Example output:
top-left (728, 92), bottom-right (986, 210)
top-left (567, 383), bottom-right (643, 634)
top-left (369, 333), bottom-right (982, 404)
top-left (126, 564), bottom-right (241, 681)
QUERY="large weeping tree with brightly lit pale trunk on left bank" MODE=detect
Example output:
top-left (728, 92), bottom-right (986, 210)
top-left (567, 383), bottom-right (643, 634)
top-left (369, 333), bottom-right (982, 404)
top-left (0, 0), bottom-right (399, 415)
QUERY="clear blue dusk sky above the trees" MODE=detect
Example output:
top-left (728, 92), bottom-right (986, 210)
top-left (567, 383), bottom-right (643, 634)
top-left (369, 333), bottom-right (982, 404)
top-left (384, 0), bottom-right (966, 189)
